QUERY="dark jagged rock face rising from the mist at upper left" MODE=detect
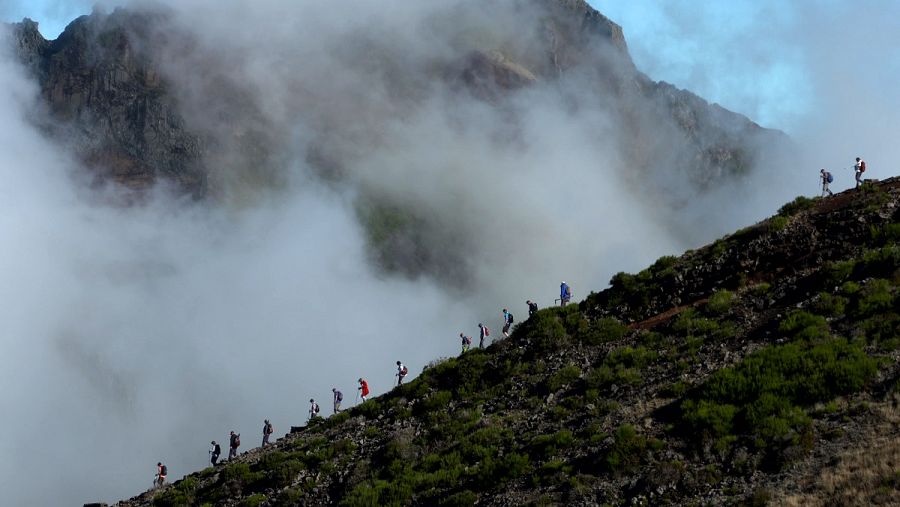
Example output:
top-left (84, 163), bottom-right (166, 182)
top-left (14, 10), bottom-right (206, 196)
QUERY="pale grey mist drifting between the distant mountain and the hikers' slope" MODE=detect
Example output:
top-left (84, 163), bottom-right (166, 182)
top-left (0, 0), bottom-right (896, 505)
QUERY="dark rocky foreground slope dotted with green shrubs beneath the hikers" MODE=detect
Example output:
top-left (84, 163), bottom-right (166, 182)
top-left (119, 179), bottom-right (900, 507)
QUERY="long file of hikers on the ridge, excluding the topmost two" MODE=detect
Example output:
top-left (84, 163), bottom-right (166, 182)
top-left (153, 282), bottom-right (572, 488)
